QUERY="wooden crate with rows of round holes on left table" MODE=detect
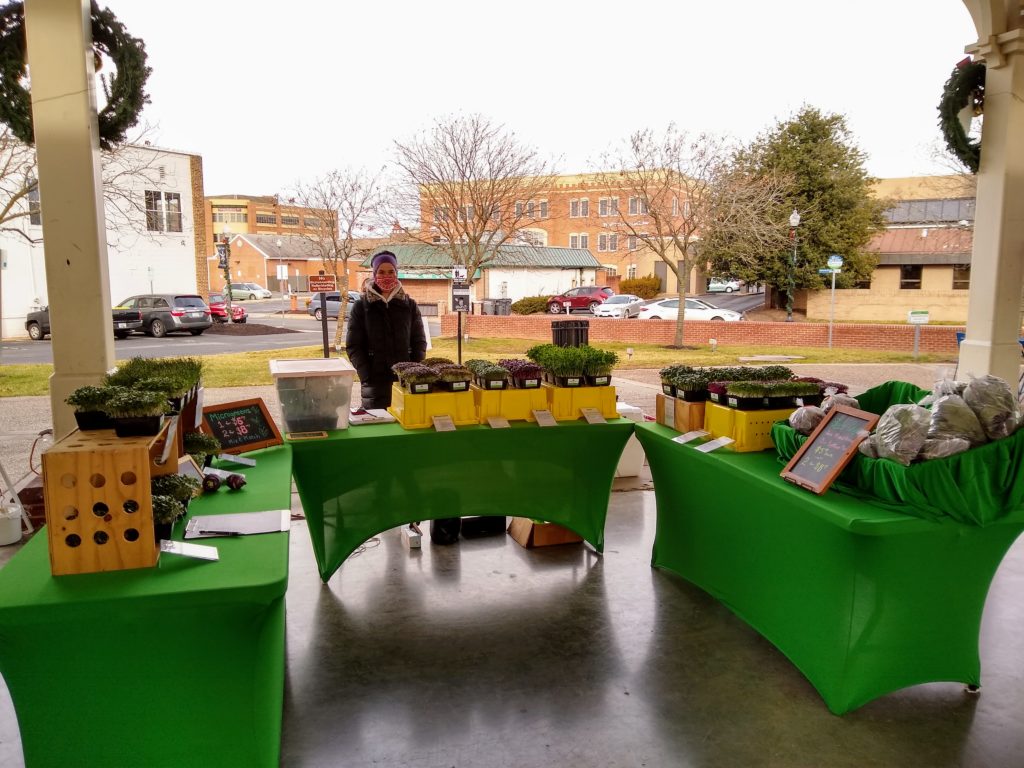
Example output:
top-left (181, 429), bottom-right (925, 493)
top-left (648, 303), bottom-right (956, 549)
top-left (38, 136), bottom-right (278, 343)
top-left (43, 425), bottom-right (177, 575)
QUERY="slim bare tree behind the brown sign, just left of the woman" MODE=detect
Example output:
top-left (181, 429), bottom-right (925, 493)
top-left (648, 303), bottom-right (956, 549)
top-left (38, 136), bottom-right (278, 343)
top-left (296, 168), bottom-right (381, 348)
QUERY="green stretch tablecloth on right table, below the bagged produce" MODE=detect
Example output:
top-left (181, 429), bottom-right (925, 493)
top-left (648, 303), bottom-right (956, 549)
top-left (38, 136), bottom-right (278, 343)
top-left (636, 424), bottom-right (1024, 714)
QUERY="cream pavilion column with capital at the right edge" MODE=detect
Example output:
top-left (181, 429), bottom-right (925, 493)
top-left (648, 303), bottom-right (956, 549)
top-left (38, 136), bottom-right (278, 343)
top-left (959, 29), bottom-right (1024, 391)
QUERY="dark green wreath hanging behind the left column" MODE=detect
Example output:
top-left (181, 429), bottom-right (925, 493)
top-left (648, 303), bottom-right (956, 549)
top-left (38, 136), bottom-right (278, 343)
top-left (0, 2), bottom-right (152, 150)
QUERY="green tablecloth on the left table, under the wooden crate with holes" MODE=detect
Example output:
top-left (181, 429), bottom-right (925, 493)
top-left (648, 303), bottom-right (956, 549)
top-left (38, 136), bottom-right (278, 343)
top-left (0, 445), bottom-right (291, 768)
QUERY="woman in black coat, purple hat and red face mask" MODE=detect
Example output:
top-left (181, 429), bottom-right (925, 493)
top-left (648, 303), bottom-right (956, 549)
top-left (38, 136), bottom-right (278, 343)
top-left (345, 251), bottom-right (427, 409)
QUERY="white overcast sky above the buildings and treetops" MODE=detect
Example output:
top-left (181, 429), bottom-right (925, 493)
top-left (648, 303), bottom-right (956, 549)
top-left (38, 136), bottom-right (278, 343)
top-left (110, 0), bottom-right (976, 195)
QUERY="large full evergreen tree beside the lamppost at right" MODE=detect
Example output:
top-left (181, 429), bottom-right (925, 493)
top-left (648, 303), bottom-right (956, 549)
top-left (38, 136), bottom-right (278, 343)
top-left (705, 105), bottom-right (885, 292)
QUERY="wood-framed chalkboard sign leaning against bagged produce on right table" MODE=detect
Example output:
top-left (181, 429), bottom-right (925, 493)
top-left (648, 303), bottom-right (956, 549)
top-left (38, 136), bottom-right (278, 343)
top-left (782, 406), bottom-right (879, 495)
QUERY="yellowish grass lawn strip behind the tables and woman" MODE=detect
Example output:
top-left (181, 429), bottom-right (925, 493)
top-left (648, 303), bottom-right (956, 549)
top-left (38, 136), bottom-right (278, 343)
top-left (0, 338), bottom-right (953, 397)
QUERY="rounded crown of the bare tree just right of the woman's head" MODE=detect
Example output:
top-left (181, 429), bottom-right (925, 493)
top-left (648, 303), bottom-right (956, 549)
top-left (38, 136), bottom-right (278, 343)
top-left (389, 115), bottom-right (553, 283)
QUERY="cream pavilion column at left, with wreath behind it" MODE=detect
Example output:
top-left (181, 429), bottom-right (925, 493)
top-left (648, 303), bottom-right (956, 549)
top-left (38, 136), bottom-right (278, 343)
top-left (25, 0), bottom-right (114, 439)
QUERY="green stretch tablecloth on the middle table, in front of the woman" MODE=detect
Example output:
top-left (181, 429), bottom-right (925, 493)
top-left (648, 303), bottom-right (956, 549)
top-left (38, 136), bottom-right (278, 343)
top-left (292, 419), bottom-right (633, 582)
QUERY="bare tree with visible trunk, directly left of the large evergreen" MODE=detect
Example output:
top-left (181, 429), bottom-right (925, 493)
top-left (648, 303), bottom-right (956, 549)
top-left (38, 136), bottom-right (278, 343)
top-left (601, 125), bottom-right (785, 347)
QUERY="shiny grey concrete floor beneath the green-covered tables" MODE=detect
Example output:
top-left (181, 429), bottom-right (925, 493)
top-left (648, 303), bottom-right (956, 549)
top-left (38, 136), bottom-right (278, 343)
top-left (0, 480), bottom-right (1024, 768)
